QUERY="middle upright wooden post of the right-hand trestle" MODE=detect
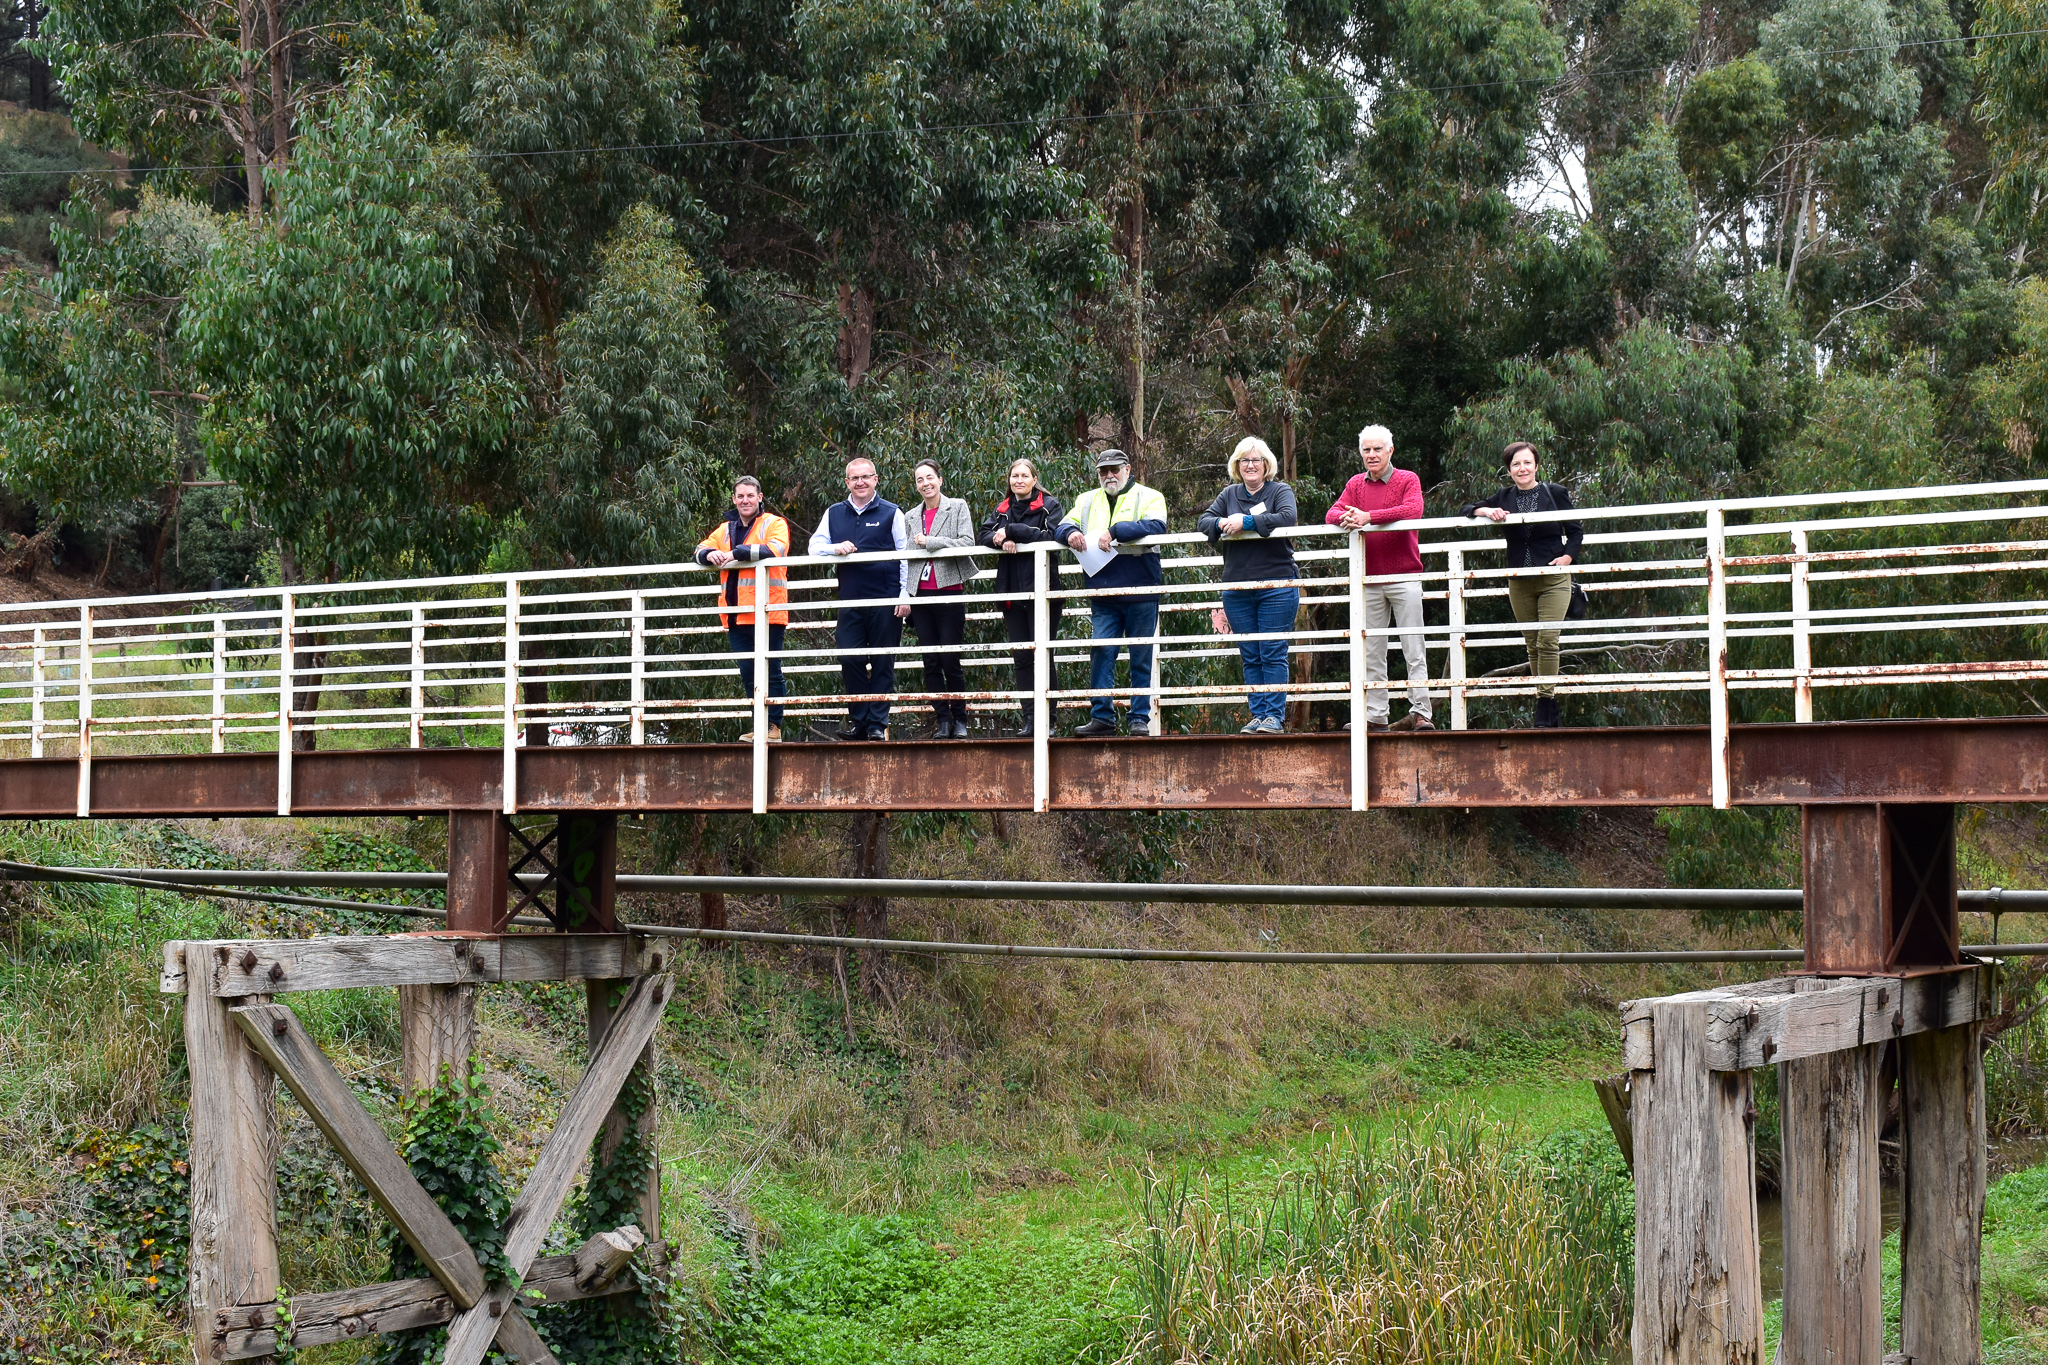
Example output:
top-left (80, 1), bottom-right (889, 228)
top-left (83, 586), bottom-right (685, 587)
top-left (1778, 1044), bottom-right (1884, 1365)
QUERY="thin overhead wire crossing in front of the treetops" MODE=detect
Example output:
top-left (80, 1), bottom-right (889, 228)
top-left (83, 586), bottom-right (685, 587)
top-left (19, 27), bottom-right (2048, 178)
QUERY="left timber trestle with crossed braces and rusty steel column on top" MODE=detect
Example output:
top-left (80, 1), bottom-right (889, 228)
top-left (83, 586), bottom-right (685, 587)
top-left (173, 810), bottom-right (676, 1365)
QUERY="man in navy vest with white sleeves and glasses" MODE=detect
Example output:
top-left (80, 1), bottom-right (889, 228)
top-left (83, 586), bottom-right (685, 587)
top-left (811, 456), bottom-right (909, 739)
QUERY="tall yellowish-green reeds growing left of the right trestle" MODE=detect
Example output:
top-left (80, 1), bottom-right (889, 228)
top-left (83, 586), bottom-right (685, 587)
top-left (1118, 1119), bottom-right (1632, 1365)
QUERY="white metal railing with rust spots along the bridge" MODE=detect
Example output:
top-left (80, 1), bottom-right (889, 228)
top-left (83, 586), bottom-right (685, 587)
top-left (0, 481), bottom-right (2048, 814)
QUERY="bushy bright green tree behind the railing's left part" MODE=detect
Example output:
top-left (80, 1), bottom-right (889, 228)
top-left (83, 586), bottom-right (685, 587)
top-left (180, 90), bottom-right (518, 579)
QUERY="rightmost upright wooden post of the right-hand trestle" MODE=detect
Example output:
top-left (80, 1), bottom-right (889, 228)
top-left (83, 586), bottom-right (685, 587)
top-left (1898, 1023), bottom-right (1985, 1365)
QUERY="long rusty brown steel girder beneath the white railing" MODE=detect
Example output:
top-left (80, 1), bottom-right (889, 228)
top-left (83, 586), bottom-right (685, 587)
top-left (0, 718), bottom-right (2048, 819)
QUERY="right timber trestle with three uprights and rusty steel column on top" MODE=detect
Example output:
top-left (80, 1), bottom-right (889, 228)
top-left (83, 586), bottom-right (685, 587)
top-left (1622, 804), bottom-right (1997, 1365)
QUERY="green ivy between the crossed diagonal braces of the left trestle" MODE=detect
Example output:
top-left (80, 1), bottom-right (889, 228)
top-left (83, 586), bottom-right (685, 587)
top-left (373, 1060), bottom-right (518, 1365)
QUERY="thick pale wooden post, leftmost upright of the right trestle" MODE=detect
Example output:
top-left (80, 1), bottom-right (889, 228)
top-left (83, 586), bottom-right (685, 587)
top-left (1630, 999), bottom-right (1763, 1365)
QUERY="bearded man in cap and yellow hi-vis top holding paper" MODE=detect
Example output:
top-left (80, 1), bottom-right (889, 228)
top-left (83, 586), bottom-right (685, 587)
top-left (1053, 450), bottom-right (1165, 739)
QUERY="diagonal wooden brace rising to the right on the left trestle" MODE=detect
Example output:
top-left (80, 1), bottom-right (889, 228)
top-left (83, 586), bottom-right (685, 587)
top-left (442, 970), bottom-right (674, 1365)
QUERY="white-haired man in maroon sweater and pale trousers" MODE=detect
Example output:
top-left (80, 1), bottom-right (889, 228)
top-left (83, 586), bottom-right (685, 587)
top-left (1323, 426), bottom-right (1436, 731)
